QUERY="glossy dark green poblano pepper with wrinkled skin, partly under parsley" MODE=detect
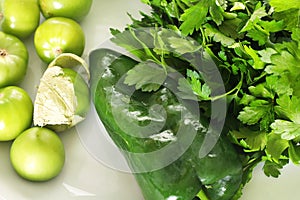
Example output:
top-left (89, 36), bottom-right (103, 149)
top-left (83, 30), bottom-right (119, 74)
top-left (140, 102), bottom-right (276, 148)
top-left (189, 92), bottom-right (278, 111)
top-left (90, 49), bottom-right (242, 200)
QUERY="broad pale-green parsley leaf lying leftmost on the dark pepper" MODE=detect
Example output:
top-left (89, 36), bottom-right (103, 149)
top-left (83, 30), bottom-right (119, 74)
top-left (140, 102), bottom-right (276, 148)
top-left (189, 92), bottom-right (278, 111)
top-left (124, 61), bottom-right (167, 92)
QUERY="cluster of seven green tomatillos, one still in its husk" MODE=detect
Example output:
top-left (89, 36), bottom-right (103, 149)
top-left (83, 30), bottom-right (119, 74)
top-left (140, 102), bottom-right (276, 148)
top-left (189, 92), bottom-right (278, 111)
top-left (0, 0), bottom-right (92, 181)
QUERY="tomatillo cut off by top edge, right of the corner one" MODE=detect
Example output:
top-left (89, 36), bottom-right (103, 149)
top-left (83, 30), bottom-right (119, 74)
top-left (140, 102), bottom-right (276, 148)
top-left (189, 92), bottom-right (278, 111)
top-left (39, 0), bottom-right (93, 22)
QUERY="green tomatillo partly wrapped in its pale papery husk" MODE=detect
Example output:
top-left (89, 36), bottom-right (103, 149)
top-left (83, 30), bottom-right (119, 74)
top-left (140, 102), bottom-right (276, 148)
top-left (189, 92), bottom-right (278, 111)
top-left (33, 52), bottom-right (90, 132)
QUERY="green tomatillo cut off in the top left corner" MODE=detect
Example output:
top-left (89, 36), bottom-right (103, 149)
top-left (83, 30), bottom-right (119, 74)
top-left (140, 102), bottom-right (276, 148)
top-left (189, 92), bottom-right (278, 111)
top-left (0, 0), bottom-right (40, 39)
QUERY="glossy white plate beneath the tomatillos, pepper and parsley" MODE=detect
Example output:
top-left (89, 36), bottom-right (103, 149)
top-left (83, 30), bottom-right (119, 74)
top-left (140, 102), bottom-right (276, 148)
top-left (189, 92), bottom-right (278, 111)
top-left (0, 0), bottom-right (300, 200)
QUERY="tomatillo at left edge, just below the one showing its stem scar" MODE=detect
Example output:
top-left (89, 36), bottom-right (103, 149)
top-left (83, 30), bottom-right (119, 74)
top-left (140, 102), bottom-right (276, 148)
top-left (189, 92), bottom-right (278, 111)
top-left (0, 86), bottom-right (33, 141)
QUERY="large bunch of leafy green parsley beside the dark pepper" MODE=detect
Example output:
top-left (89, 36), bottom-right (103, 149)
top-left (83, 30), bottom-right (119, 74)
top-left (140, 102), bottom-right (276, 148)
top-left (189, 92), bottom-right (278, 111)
top-left (111, 0), bottom-right (300, 195)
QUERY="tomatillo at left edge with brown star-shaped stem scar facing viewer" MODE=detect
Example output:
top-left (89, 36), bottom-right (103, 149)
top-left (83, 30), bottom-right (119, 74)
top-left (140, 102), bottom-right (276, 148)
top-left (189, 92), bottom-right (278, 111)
top-left (0, 31), bottom-right (28, 88)
